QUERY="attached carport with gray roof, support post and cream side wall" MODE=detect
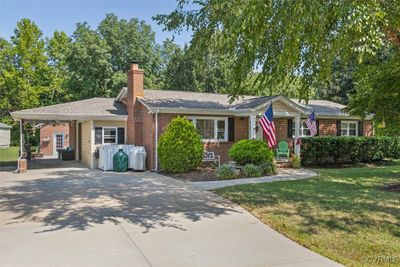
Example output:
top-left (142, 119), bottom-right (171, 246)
top-left (11, 98), bottom-right (128, 169)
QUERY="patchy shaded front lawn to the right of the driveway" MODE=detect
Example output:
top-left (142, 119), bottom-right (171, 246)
top-left (215, 165), bottom-right (400, 266)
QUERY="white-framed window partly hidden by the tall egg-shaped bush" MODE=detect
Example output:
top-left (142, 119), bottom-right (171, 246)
top-left (189, 117), bottom-right (228, 142)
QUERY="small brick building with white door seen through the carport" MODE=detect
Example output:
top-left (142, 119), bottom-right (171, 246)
top-left (39, 122), bottom-right (70, 157)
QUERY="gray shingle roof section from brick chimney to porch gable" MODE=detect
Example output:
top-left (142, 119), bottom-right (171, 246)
top-left (141, 90), bottom-right (276, 110)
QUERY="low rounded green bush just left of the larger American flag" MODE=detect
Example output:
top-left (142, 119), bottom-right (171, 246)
top-left (229, 140), bottom-right (274, 166)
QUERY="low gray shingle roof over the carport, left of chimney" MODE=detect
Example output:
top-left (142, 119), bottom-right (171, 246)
top-left (11, 97), bottom-right (127, 116)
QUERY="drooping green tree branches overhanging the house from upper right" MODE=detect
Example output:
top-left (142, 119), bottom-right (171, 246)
top-left (155, 0), bottom-right (400, 98)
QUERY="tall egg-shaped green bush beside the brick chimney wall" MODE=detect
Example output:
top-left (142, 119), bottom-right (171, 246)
top-left (158, 117), bottom-right (204, 173)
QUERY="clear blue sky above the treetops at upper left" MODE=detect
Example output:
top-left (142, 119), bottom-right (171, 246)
top-left (0, 0), bottom-right (191, 45)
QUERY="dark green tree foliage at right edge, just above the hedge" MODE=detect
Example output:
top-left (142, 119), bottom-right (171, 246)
top-left (349, 47), bottom-right (400, 136)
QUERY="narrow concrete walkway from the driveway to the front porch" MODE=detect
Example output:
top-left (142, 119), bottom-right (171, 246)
top-left (189, 169), bottom-right (317, 190)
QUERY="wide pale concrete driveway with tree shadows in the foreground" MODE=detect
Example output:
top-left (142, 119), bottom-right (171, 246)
top-left (0, 163), bottom-right (337, 267)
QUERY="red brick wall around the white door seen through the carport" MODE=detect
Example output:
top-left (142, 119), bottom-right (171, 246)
top-left (40, 123), bottom-right (70, 156)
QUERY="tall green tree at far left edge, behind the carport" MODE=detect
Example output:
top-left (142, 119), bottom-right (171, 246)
top-left (0, 19), bottom-right (52, 144)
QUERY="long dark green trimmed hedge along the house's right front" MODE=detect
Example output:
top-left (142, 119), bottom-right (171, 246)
top-left (301, 136), bottom-right (400, 166)
